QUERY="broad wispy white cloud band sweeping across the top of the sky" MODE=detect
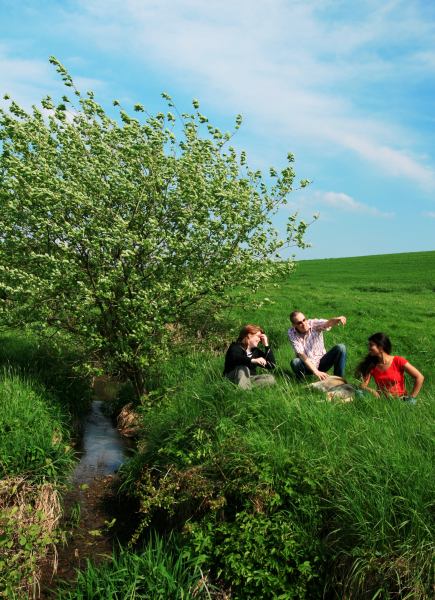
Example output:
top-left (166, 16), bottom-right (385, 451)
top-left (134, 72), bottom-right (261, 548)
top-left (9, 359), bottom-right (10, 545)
top-left (63, 0), bottom-right (435, 190)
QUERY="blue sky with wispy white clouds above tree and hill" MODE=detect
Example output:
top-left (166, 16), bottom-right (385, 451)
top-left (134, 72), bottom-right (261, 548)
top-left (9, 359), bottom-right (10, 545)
top-left (0, 0), bottom-right (435, 259)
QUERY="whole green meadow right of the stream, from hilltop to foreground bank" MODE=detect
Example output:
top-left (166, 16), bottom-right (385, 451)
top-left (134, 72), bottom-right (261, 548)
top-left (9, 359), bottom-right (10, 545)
top-left (0, 252), bottom-right (435, 600)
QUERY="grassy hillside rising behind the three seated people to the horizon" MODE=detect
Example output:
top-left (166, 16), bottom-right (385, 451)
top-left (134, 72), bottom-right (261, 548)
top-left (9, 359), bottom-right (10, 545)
top-left (228, 252), bottom-right (435, 386)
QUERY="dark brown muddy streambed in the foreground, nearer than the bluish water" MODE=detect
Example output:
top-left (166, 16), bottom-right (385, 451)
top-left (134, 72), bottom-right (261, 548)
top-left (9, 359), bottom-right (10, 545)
top-left (40, 475), bottom-right (135, 600)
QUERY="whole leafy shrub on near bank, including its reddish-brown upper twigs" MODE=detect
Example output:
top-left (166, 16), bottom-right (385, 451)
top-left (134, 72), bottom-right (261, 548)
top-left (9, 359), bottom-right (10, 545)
top-left (184, 463), bottom-right (322, 600)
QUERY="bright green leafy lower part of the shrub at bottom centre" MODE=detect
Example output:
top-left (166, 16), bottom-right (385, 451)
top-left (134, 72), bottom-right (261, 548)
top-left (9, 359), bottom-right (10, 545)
top-left (189, 510), bottom-right (319, 600)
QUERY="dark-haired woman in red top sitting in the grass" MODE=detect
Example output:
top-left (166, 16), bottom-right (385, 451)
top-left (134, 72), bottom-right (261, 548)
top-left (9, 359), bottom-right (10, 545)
top-left (357, 333), bottom-right (424, 402)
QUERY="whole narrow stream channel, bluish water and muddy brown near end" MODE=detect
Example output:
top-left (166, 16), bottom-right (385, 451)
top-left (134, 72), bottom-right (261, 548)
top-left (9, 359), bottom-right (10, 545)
top-left (40, 385), bottom-right (135, 600)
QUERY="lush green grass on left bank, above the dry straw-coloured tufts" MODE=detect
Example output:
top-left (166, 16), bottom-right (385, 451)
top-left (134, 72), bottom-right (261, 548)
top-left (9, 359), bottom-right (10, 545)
top-left (0, 332), bottom-right (90, 482)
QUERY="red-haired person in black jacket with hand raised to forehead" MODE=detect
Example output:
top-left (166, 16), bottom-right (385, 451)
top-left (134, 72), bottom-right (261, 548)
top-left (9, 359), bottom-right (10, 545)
top-left (224, 324), bottom-right (276, 390)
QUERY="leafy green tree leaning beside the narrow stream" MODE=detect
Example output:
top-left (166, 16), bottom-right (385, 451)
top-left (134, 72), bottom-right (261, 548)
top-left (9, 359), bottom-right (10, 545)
top-left (0, 57), bottom-right (314, 394)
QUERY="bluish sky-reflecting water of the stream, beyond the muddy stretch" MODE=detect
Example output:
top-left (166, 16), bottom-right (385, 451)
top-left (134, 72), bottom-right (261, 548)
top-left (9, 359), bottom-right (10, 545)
top-left (72, 400), bottom-right (127, 485)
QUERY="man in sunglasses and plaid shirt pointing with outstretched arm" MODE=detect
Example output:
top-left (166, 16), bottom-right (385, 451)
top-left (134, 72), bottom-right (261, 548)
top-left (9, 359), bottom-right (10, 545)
top-left (288, 310), bottom-right (346, 380)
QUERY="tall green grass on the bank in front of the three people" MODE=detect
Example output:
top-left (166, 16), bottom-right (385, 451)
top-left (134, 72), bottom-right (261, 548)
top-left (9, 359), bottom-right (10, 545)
top-left (118, 356), bottom-right (434, 598)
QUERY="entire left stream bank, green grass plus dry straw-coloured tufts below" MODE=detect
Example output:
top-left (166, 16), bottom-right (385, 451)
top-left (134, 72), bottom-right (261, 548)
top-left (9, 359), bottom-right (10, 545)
top-left (0, 332), bottom-right (90, 598)
